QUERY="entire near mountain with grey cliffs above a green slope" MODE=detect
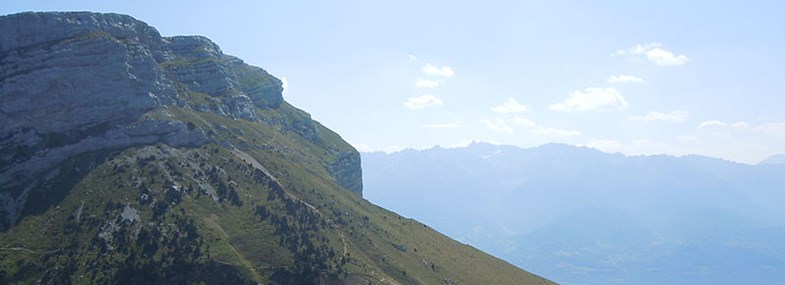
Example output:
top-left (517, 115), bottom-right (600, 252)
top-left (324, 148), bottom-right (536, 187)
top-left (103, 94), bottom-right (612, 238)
top-left (0, 12), bottom-right (553, 284)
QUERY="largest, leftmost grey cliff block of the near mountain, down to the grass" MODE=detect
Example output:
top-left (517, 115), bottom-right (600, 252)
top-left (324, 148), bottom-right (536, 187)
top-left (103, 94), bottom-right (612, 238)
top-left (0, 13), bottom-right (187, 209)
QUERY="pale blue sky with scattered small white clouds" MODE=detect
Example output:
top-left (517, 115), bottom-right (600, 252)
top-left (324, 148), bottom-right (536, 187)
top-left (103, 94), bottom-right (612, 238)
top-left (0, 0), bottom-right (785, 163)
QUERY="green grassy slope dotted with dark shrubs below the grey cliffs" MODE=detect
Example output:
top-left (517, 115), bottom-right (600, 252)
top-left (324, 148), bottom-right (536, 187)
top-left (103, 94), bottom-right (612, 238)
top-left (0, 89), bottom-right (551, 284)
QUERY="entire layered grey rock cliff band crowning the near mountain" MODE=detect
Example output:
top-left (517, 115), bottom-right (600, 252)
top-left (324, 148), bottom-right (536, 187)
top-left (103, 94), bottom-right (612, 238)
top-left (0, 12), bottom-right (362, 229)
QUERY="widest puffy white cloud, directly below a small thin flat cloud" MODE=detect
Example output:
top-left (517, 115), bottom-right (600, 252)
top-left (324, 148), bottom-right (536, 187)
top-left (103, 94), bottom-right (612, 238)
top-left (549, 87), bottom-right (628, 112)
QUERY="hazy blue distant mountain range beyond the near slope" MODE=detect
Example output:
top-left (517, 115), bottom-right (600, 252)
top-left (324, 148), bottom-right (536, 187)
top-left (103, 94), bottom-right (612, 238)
top-left (362, 143), bottom-right (785, 285)
